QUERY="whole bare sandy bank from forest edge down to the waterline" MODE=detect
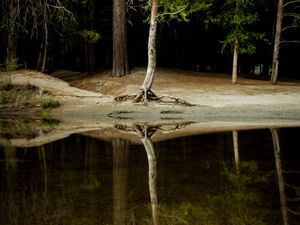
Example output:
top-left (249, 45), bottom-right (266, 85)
top-left (7, 68), bottom-right (300, 121)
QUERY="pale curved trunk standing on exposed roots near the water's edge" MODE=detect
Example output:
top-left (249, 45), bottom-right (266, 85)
top-left (133, 0), bottom-right (158, 103)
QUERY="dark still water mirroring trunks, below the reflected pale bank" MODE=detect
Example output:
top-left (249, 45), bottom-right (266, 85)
top-left (0, 128), bottom-right (300, 225)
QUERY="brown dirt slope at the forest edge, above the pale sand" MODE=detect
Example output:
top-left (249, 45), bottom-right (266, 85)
top-left (70, 68), bottom-right (300, 96)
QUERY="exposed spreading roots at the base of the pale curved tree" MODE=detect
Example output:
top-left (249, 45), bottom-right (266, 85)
top-left (114, 89), bottom-right (193, 106)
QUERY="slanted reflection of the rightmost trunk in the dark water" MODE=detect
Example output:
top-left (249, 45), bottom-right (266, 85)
top-left (271, 129), bottom-right (289, 225)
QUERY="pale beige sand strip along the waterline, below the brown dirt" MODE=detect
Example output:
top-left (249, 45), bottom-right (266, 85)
top-left (11, 71), bottom-right (300, 126)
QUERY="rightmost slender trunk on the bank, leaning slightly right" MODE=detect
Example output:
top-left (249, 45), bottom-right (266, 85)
top-left (271, 0), bottom-right (283, 84)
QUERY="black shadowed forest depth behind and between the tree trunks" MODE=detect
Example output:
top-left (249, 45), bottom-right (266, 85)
top-left (0, 0), bottom-right (300, 79)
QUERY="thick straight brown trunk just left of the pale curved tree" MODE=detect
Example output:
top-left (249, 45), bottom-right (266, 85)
top-left (112, 0), bottom-right (129, 77)
